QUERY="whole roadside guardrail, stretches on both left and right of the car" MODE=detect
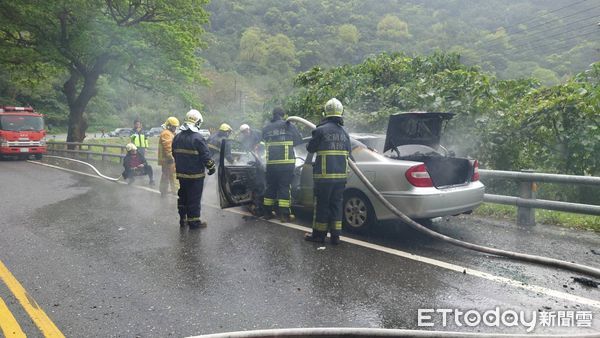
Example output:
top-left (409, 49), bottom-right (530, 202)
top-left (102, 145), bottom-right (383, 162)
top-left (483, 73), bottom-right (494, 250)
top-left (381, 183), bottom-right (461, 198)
top-left (48, 141), bottom-right (600, 225)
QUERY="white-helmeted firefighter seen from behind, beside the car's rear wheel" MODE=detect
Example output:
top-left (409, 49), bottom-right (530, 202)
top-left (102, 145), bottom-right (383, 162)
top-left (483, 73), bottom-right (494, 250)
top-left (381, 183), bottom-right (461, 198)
top-left (304, 98), bottom-right (352, 244)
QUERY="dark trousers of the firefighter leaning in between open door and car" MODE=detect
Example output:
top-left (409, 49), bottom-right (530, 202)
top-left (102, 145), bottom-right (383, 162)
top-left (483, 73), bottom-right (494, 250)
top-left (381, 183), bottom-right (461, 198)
top-left (263, 164), bottom-right (294, 216)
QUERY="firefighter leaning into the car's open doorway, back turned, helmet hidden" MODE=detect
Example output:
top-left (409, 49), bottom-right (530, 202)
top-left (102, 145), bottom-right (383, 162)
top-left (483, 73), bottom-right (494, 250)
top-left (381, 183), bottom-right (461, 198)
top-left (262, 107), bottom-right (302, 222)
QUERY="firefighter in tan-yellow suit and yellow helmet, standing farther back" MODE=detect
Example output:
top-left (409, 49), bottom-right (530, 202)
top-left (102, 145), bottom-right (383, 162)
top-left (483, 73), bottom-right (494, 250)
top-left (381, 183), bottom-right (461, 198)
top-left (158, 116), bottom-right (179, 197)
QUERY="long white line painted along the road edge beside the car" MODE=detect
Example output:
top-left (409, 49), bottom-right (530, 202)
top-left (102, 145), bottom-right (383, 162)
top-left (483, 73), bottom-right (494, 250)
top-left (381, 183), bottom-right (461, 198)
top-left (29, 161), bottom-right (600, 308)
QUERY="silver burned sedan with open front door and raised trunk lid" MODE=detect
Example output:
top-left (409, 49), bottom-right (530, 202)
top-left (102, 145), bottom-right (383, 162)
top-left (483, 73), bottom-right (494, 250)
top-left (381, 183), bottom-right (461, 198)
top-left (218, 112), bottom-right (484, 230)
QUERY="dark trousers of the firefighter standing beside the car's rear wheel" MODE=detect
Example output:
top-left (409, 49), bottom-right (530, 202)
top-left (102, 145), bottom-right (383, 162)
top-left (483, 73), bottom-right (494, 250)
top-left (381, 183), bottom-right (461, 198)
top-left (313, 181), bottom-right (346, 237)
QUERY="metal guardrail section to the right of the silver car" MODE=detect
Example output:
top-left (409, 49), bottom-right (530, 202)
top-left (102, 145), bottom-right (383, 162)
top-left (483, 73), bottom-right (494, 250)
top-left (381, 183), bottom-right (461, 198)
top-left (479, 169), bottom-right (600, 225)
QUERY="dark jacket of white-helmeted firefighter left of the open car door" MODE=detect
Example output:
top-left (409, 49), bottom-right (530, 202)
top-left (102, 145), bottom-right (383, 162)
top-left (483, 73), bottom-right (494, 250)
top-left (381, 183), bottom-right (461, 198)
top-left (172, 130), bottom-right (215, 179)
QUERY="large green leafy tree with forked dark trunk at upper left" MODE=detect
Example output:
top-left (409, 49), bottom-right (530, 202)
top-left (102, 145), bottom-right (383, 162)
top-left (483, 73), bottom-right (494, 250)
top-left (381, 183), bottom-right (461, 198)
top-left (0, 0), bottom-right (207, 142)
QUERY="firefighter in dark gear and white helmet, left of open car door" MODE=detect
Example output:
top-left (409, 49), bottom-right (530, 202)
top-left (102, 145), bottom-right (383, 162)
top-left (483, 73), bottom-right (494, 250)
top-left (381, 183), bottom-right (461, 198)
top-left (172, 109), bottom-right (215, 229)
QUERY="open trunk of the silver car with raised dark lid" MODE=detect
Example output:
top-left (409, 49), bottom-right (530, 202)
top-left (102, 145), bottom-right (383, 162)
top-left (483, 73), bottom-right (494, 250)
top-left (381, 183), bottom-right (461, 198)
top-left (384, 112), bottom-right (473, 188)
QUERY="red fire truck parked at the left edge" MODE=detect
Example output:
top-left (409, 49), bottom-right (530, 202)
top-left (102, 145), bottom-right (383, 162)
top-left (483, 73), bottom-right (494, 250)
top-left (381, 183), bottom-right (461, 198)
top-left (0, 106), bottom-right (46, 159)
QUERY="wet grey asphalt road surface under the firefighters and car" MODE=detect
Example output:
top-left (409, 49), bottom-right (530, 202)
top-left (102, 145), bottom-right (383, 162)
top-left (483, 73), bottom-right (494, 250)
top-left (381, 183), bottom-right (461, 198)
top-left (0, 161), bottom-right (600, 337)
